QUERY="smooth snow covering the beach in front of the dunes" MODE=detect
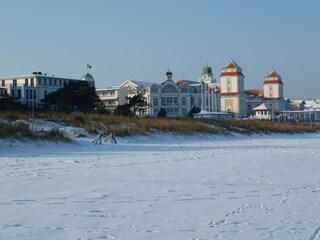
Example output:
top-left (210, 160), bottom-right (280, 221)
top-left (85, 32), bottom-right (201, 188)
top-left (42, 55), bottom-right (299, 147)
top-left (0, 133), bottom-right (320, 240)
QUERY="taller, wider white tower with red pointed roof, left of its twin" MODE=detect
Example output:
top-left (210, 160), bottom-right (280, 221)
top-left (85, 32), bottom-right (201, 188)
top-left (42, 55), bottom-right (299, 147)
top-left (220, 60), bottom-right (247, 117)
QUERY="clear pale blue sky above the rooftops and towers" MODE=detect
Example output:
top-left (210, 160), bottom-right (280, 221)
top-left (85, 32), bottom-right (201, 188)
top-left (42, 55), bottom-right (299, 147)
top-left (0, 0), bottom-right (320, 99)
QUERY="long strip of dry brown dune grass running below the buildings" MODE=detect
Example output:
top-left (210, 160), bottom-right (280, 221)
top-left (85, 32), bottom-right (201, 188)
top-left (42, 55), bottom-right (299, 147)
top-left (0, 112), bottom-right (319, 139)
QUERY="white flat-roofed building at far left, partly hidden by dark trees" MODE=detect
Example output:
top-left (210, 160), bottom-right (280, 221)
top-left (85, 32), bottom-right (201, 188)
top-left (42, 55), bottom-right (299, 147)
top-left (0, 72), bottom-right (94, 107)
